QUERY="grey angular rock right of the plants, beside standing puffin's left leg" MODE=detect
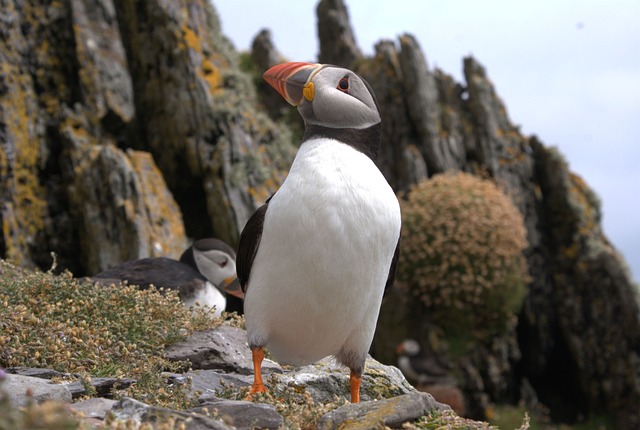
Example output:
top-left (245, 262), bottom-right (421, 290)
top-left (165, 325), bottom-right (282, 375)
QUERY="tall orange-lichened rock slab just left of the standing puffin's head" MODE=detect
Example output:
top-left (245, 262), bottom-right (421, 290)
top-left (114, 0), bottom-right (295, 245)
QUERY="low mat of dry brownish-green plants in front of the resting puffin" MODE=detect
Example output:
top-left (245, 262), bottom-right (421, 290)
top-left (0, 260), bottom-right (228, 408)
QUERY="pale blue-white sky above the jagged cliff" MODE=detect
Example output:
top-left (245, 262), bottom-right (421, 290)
top-left (213, 0), bottom-right (640, 282)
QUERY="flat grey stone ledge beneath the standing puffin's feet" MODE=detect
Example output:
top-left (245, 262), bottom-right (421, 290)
top-left (0, 325), bottom-right (450, 429)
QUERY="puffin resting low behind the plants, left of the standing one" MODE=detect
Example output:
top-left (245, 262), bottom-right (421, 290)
top-left (91, 238), bottom-right (244, 315)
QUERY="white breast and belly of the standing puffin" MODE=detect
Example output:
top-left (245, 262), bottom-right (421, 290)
top-left (245, 138), bottom-right (400, 365)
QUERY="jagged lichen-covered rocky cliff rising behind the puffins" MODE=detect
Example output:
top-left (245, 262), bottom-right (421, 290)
top-left (0, 0), bottom-right (640, 429)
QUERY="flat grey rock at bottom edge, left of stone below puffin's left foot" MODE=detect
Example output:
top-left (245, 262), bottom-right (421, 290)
top-left (111, 397), bottom-right (233, 430)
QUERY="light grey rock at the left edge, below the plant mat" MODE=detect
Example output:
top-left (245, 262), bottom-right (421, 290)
top-left (2, 374), bottom-right (71, 406)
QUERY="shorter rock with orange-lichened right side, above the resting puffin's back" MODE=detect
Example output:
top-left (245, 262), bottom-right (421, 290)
top-left (69, 143), bottom-right (186, 273)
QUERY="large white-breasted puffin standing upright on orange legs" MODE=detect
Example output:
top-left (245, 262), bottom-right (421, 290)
top-left (237, 62), bottom-right (401, 403)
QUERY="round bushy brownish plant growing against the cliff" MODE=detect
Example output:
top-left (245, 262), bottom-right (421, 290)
top-left (398, 173), bottom-right (528, 339)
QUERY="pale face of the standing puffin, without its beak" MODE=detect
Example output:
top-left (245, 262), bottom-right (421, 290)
top-left (298, 66), bottom-right (380, 129)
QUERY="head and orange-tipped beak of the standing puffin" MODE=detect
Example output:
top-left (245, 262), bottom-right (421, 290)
top-left (263, 62), bottom-right (380, 130)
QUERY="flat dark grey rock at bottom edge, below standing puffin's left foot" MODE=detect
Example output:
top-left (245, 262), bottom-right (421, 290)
top-left (189, 399), bottom-right (284, 430)
